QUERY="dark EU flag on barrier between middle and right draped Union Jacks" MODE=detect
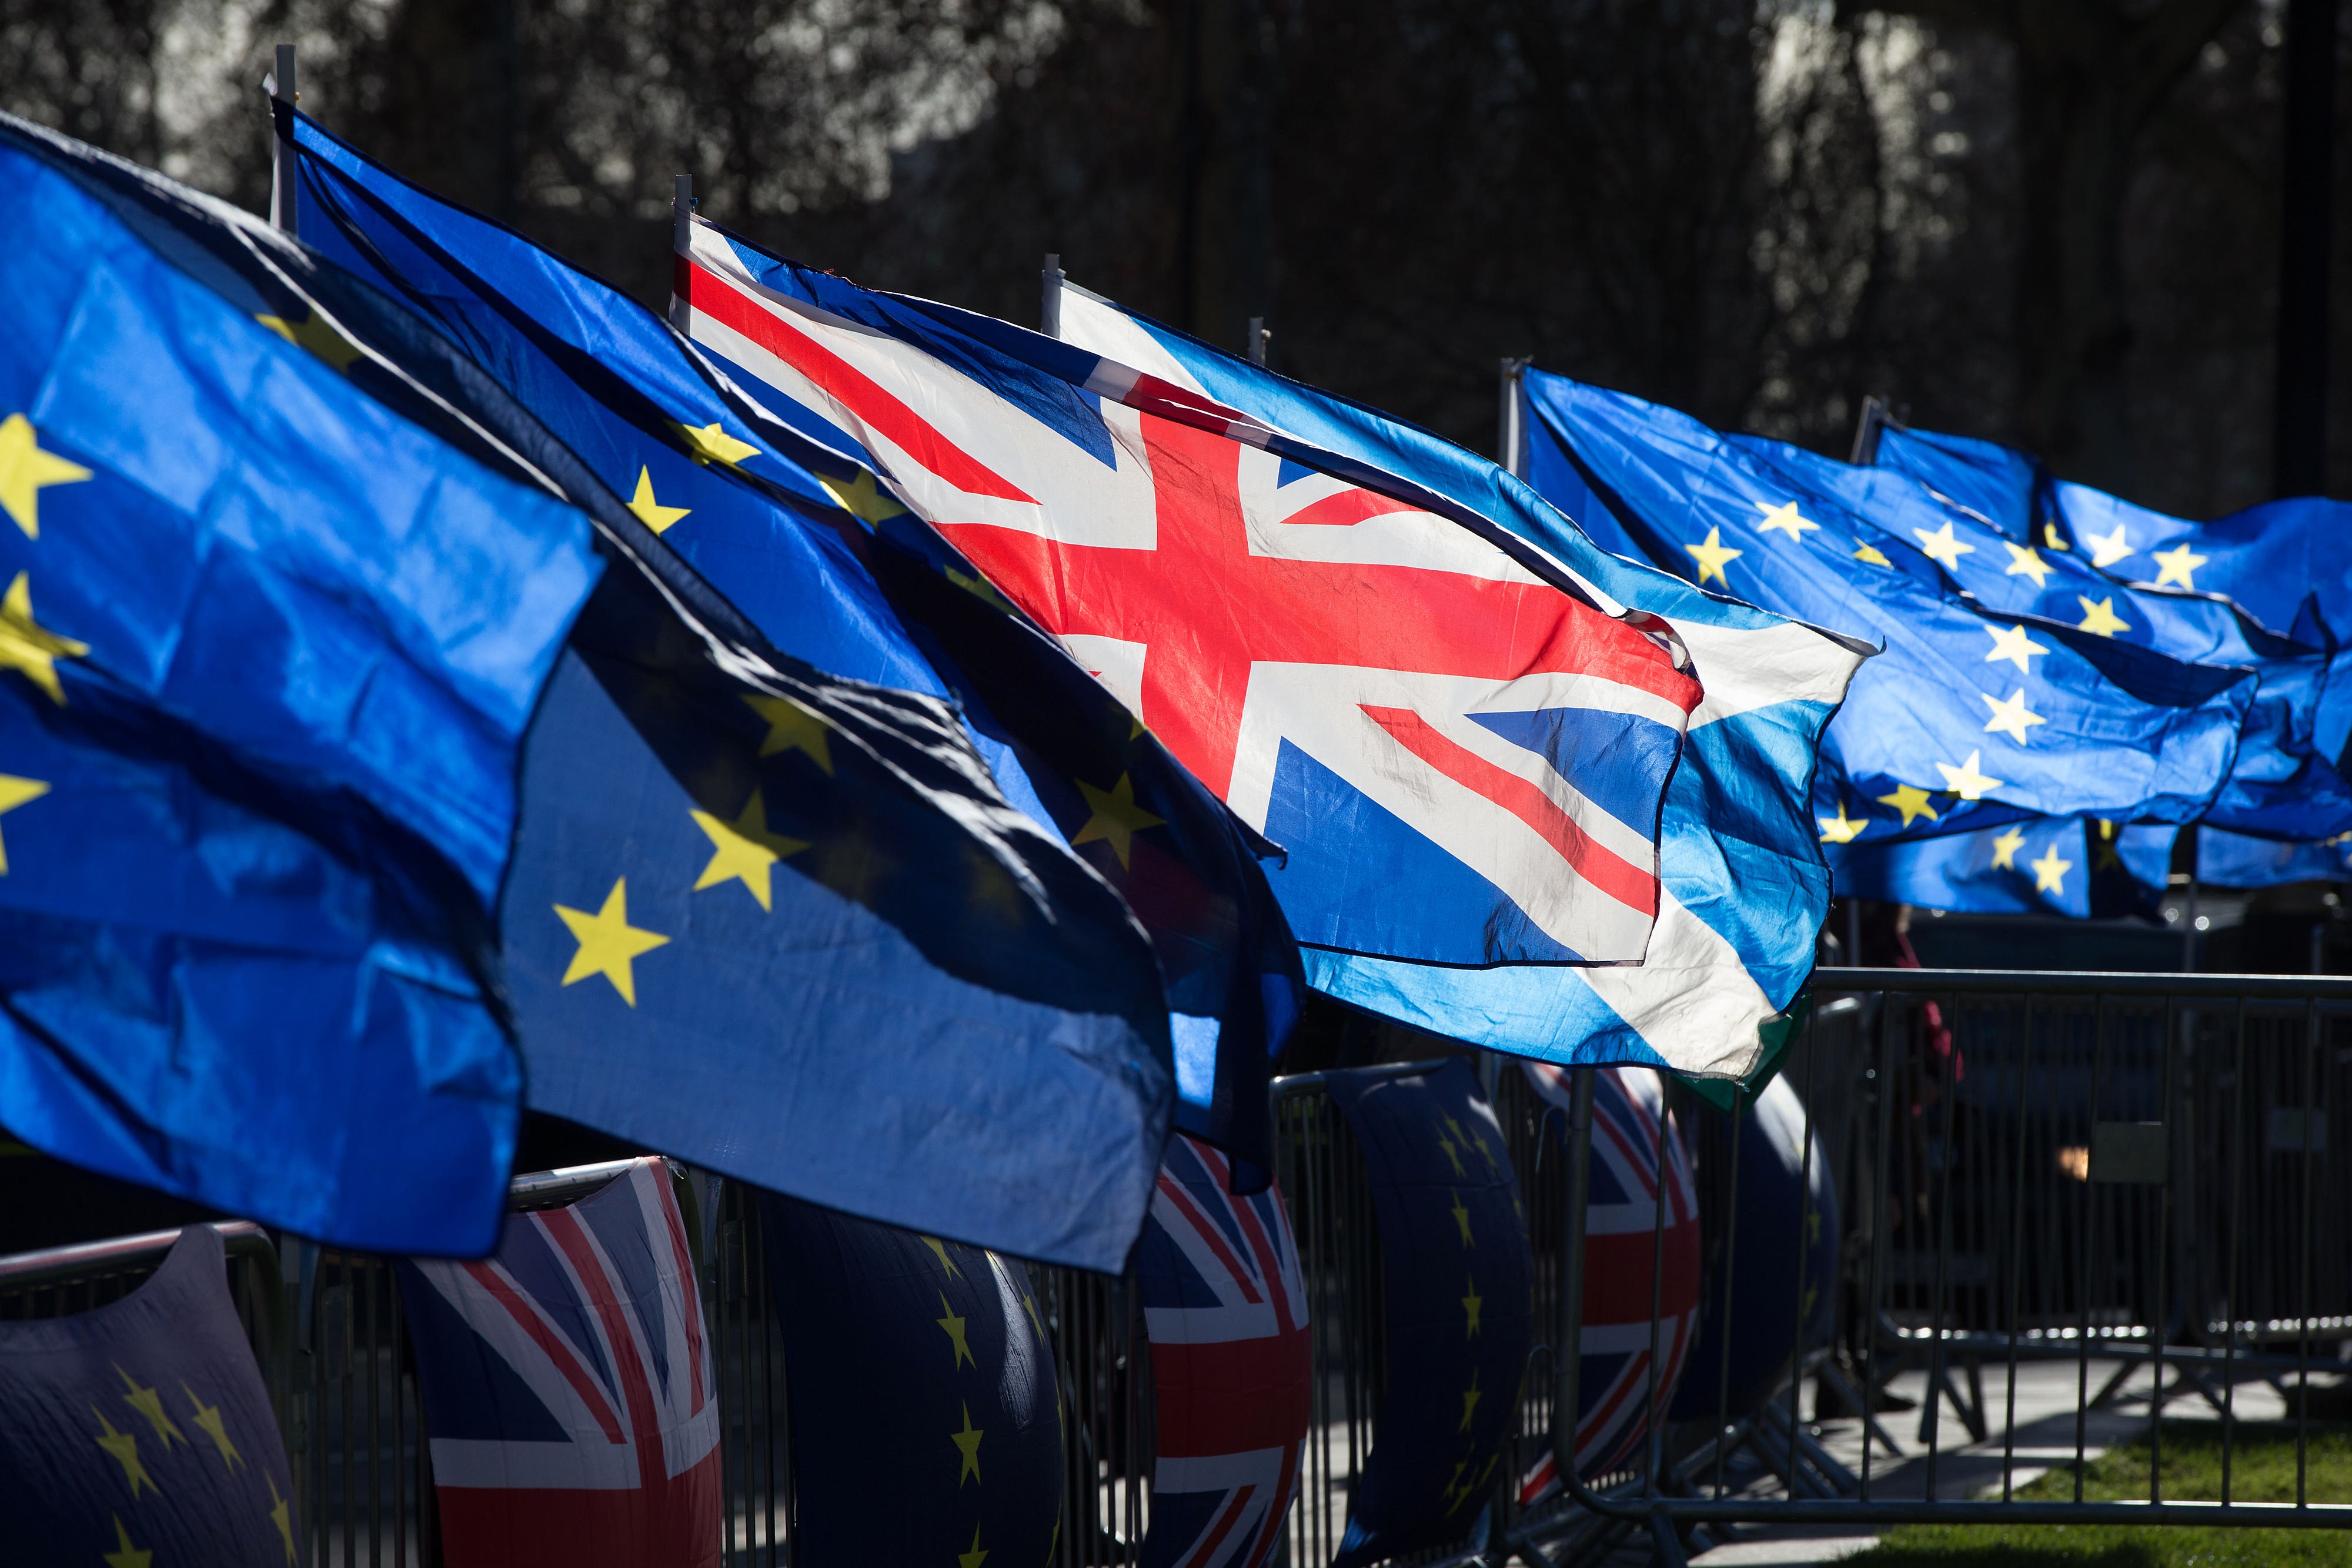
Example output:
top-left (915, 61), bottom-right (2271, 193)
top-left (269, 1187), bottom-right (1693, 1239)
top-left (1329, 1058), bottom-right (1534, 1568)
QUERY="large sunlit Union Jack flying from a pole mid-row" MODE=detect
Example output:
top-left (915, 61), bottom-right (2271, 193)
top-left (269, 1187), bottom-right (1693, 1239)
top-left (675, 219), bottom-right (1700, 964)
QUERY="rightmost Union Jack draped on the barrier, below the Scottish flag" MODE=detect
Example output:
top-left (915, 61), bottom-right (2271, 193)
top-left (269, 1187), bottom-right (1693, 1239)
top-left (1519, 1062), bottom-right (1698, 1505)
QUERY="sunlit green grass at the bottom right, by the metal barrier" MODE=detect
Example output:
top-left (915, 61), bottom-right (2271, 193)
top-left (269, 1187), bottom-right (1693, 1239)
top-left (1851, 1420), bottom-right (2352, 1568)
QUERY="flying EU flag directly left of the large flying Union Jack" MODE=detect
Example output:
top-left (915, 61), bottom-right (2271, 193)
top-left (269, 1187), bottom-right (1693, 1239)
top-left (280, 106), bottom-right (1305, 1189)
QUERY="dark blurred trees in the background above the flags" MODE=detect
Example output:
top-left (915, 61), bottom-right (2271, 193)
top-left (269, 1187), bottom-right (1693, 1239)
top-left (0, 0), bottom-right (2352, 517)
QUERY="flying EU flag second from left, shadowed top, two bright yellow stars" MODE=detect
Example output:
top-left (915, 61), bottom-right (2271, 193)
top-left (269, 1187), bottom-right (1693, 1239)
top-left (16, 116), bottom-right (1174, 1269)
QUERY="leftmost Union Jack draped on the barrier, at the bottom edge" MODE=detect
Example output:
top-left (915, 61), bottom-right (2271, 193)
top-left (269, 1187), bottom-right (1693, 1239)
top-left (400, 1159), bottom-right (720, 1568)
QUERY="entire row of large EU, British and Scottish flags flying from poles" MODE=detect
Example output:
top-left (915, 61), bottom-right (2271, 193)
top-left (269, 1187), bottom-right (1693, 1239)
top-left (0, 79), bottom-right (2352, 1269)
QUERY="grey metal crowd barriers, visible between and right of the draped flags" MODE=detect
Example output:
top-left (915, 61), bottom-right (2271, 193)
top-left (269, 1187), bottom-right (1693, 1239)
top-left (14, 968), bottom-right (2352, 1568)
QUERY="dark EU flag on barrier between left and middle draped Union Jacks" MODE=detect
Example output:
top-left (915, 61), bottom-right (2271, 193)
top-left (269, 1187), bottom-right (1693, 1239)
top-left (760, 1199), bottom-right (1068, 1568)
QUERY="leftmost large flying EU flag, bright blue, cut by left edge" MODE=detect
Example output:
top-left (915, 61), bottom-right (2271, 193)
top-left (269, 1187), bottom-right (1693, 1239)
top-left (0, 120), bottom-right (600, 1253)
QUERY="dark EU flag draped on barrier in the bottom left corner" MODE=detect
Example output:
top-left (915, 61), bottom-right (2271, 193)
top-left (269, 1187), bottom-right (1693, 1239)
top-left (0, 1225), bottom-right (299, 1568)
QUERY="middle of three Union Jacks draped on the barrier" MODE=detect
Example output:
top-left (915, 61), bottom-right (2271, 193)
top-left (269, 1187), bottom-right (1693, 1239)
top-left (1136, 1133), bottom-right (1310, 1568)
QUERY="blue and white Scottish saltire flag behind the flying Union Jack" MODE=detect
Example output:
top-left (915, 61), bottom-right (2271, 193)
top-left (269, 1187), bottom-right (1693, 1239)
top-left (1058, 287), bottom-right (1863, 1076)
